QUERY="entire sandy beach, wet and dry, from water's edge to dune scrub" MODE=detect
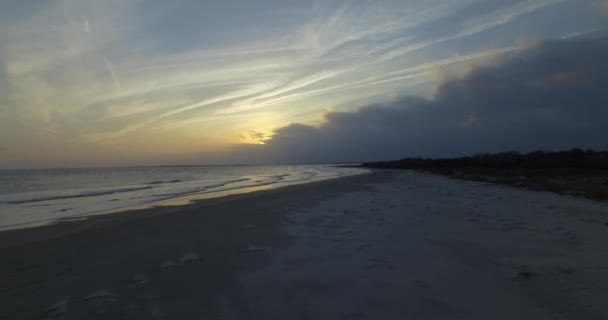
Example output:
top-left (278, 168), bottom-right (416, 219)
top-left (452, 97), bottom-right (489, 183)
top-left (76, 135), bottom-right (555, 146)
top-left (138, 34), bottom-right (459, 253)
top-left (0, 170), bottom-right (608, 319)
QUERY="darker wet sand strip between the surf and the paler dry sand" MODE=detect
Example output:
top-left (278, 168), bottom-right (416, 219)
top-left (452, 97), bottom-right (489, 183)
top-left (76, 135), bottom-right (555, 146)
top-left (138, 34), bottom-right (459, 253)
top-left (0, 174), bottom-right (389, 319)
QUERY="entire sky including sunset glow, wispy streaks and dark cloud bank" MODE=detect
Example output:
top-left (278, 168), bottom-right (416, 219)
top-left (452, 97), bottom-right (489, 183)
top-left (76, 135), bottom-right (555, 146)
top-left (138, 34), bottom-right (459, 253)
top-left (0, 0), bottom-right (608, 169)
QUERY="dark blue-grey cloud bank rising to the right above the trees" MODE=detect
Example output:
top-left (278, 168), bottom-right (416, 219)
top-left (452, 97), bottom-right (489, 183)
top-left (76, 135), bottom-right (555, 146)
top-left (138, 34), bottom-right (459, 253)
top-left (235, 36), bottom-right (608, 162)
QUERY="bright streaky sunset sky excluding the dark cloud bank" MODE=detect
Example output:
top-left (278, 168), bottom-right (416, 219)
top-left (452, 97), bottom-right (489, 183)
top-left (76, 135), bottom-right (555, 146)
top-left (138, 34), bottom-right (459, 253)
top-left (0, 0), bottom-right (608, 168)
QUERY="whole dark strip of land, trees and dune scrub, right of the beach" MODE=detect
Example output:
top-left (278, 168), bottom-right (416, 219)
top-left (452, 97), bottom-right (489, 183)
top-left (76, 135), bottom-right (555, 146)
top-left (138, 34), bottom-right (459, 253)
top-left (361, 149), bottom-right (608, 201)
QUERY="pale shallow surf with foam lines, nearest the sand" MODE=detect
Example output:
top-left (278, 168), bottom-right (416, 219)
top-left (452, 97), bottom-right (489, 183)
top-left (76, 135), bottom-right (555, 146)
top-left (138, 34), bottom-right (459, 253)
top-left (0, 166), bottom-right (365, 231)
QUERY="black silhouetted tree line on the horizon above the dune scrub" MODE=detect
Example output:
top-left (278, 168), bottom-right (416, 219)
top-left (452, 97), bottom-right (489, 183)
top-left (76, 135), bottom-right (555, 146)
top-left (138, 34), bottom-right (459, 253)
top-left (362, 149), bottom-right (608, 169)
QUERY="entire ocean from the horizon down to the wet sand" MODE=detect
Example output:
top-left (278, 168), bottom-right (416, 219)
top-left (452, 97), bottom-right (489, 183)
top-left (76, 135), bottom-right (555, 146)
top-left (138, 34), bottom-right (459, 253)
top-left (0, 165), bottom-right (366, 231)
